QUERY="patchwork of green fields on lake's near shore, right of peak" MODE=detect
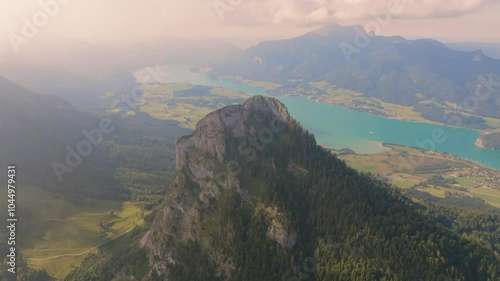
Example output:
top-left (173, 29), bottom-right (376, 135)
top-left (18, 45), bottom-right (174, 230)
top-left (334, 144), bottom-right (500, 208)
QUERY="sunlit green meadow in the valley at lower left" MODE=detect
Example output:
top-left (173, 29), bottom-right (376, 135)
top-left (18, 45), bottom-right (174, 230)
top-left (5, 186), bottom-right (146, 280)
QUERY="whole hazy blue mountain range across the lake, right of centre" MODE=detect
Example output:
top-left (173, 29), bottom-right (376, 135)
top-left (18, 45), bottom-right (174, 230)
top-left (212, 25), bottom-right (500, 117)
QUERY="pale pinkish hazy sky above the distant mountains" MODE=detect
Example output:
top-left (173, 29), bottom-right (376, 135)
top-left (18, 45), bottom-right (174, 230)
top-left (0, 0), bottom-right (500, 53)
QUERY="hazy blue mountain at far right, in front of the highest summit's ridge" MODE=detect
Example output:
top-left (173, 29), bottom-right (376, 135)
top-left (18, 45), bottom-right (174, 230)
top-left (320, 37), bottom-right (500, 107)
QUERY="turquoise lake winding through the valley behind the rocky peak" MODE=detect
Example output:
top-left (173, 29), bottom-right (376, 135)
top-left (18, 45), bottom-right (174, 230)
top-left (145, 66), bottom-right (500, 169)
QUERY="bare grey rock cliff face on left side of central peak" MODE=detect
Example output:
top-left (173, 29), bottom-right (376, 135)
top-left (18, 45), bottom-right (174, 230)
top-left (141, 96), bottom-right (296, 276)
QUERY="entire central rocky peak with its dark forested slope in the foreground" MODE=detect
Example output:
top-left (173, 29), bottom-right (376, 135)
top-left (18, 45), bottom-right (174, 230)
top-left (140, 96), bottom-right (500, 281)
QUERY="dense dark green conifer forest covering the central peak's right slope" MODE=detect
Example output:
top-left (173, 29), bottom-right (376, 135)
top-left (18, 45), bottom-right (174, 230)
top-left (68, 112), bottom-right (500, 281)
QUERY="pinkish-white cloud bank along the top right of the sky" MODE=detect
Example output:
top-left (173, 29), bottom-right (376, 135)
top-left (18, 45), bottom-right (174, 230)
top-left (221, 0), bottom-right (499, 26)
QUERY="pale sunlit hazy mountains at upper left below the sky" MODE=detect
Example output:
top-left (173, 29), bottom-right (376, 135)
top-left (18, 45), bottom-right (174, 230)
top-left (0, 37), bottom-right (241, 108)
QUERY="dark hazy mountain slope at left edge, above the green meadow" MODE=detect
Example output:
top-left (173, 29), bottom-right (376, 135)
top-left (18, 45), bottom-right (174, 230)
top-left (0, 77), bottom-right (119, 197)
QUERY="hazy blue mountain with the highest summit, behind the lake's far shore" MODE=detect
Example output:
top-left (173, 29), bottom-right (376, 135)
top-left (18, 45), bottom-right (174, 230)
top-left (214, 25), bottom-right (404, 82)
